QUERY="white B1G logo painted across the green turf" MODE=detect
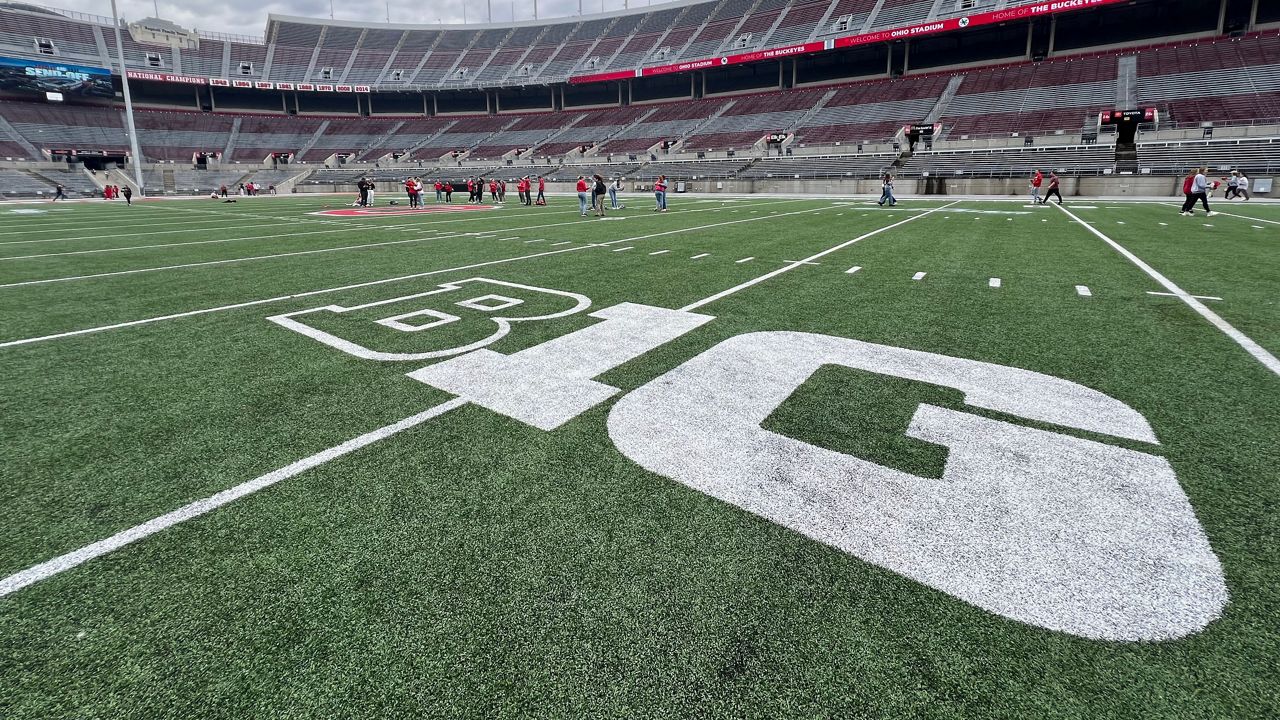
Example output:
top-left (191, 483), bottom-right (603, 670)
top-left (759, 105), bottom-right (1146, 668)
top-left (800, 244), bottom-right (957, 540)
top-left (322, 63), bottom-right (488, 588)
top-left (271, 278), bottom-right (1228, 641)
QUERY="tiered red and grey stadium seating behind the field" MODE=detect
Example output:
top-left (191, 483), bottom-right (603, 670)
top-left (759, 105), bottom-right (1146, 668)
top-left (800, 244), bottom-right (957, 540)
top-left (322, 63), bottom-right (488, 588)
top-left (0, 0), bottom-right (1280, 192)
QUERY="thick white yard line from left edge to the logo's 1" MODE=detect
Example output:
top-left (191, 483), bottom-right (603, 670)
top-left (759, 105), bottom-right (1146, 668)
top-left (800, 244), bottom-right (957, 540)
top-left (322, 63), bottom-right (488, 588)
top-left (0, 397), bottom-right (467, 597)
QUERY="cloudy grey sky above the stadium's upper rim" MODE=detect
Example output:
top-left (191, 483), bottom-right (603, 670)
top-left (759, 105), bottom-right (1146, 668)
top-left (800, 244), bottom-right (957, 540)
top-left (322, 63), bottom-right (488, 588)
top-left (49, 0), bottom-right (662, 36)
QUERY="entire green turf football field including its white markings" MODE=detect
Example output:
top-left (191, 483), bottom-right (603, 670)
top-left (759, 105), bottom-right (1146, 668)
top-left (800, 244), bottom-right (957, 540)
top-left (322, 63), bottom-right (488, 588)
top-left (0, 195), bottom-right (1280, 720)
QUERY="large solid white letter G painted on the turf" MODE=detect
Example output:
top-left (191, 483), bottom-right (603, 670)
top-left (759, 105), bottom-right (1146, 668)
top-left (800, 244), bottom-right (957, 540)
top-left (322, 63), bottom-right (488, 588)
top-left (608, 332), bottom-right (1226, 641)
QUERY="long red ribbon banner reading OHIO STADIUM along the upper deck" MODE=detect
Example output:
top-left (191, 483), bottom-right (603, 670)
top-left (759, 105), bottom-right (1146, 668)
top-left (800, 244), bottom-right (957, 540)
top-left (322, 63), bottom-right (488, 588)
top-left (568, 0), bottom-right (1129, 85)
